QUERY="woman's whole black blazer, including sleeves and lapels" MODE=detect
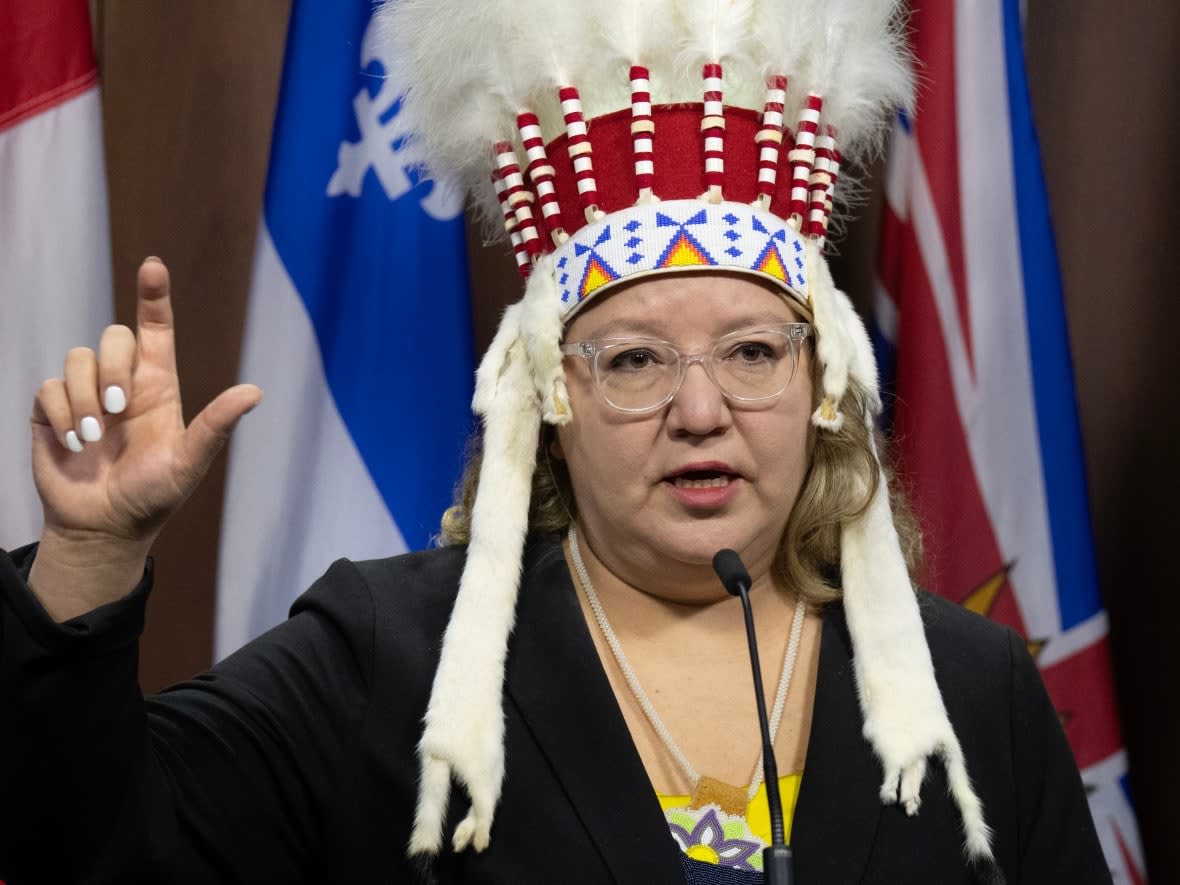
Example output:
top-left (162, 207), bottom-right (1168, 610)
top-left (0, 537), bottom-right (1110, 885)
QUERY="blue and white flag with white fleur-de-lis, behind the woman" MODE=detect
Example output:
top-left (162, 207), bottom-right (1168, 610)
top-left (215, 0), bottom-right (474, 658)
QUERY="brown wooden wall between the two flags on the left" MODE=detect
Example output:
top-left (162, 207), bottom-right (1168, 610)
top-left (96, 0), bottom-right (289, 688)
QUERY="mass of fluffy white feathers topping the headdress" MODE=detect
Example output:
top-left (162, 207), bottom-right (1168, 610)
top-left (380, 0), bottom-right (913, 246)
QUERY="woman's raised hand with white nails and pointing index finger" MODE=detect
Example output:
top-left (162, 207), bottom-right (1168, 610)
top-left (30, 258), bottom-right (262, 621)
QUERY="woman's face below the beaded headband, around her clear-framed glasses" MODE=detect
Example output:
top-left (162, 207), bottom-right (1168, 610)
top-left (553, 274), bottom-right (812, 598)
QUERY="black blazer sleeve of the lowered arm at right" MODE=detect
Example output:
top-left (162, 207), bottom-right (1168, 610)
top-left (1009, 631), bottom-right (1112, 885)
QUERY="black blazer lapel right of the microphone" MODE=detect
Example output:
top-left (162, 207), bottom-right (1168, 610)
top-left (791, 603), bottom-right (881, 884)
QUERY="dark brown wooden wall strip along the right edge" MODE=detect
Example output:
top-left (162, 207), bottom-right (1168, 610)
top-left (1027, 0), bottom-right (1180, 881)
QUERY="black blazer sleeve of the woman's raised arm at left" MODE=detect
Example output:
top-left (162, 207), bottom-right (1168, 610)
top-left (0, 548), bottom-right (374, 885)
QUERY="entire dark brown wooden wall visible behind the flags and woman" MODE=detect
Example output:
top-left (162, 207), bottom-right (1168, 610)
top-left (92, 0), bottom-right (1180, 883)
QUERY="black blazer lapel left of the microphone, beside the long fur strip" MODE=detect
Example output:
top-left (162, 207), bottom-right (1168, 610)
top-left (506, 543), bottom-right (683, 883)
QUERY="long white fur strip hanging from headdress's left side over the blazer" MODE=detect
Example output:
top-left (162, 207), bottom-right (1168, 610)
top-left (408, 312), bottom-right (540, 856)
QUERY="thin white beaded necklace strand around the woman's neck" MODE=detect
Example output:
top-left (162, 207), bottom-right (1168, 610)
top-left (568, 523), bottom-right (807, 801)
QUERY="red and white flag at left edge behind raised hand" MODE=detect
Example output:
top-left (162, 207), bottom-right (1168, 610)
top-left (0, 0), bottom-right (113, 548)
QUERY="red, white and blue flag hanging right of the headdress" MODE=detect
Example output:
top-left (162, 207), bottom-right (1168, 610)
top-left (877, 0), bottom-right (1146, 885)
